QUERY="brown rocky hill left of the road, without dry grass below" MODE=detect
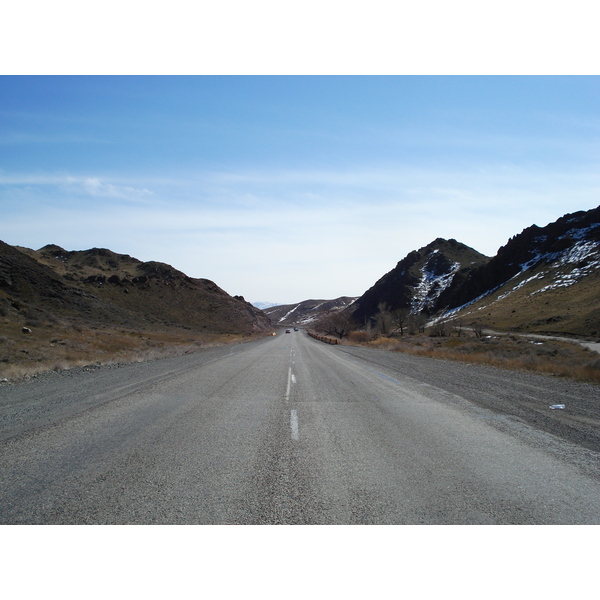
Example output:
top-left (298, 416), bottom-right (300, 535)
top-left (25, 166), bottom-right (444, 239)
top-left (0, 242), bottom-right (271, 342)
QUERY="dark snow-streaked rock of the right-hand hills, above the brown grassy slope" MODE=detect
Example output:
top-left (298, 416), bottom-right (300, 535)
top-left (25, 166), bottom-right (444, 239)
top-left (352, 207), bottom-right (600, 324)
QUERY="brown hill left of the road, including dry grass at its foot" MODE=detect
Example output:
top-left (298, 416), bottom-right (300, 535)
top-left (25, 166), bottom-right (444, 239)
top-left (0, 242), bottom-right (271, 378)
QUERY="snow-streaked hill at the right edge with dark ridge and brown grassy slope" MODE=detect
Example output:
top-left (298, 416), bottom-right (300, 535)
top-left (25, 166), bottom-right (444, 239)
top-left (439, 207), bottom-right (600, 337)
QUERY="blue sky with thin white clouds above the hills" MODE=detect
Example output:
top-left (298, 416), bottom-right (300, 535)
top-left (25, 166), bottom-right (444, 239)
top-left (0, 76), bottom-right (600, 303)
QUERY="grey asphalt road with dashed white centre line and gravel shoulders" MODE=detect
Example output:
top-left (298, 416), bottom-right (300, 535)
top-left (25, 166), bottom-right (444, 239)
top-left (0, 332), bottom-right (600, 524)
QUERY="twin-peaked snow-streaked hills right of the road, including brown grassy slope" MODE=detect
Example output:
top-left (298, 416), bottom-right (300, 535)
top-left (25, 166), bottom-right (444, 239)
top-left (351, 207), bottom-right (600, 337)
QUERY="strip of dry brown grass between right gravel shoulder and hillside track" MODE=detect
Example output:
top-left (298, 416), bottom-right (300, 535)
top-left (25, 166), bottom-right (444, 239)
top-left (345, 332), bottom-right (600, 383)
